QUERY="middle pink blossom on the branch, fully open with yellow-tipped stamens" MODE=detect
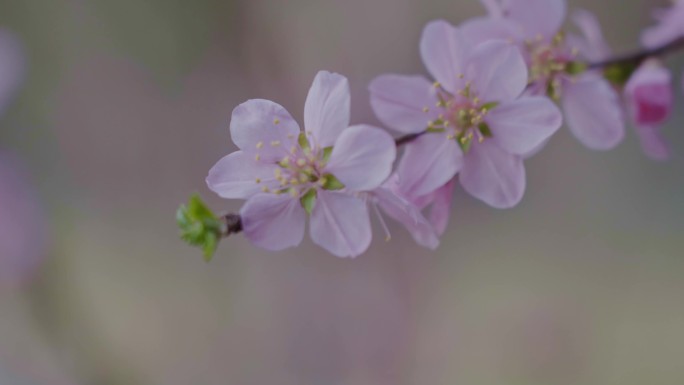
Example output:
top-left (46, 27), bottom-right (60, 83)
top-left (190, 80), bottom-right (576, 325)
top-left (369, 21), bottom-right (561, 208)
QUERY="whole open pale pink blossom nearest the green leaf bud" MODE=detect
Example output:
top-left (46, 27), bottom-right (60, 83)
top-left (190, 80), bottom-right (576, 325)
top-left (207, 71), bottom-right (396, 257)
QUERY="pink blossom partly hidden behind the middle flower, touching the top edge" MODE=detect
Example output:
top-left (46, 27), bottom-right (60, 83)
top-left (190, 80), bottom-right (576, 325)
top-left (463, 0), bottom-right (625, 150)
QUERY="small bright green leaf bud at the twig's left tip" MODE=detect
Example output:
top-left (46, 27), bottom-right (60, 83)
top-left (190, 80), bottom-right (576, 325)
top-left (176, 194), bottom-right (224, 262)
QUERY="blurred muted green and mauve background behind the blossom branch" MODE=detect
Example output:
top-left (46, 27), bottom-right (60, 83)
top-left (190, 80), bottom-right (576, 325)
top-left (0, 0), bottom-right (684, 385)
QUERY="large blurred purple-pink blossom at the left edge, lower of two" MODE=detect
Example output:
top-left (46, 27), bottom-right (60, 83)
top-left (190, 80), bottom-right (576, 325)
top-left (0, 153), bottom-right (46, 286)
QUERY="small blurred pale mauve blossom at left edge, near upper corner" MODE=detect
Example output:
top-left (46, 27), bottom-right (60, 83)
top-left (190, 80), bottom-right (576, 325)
top-left (0, 29), bottom-right (24, 114)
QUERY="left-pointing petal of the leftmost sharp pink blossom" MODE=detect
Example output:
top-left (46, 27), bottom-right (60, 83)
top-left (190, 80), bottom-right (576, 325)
top-left (207, 151), bottom-right (278, 199)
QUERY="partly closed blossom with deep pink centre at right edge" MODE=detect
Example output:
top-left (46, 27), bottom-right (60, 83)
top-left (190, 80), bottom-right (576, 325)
top-left (625, 62), bottom-right (673, 160)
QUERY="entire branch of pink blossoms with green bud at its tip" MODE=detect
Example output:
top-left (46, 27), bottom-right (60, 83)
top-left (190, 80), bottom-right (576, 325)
top-left (179, 0), bottom-right (684, 257)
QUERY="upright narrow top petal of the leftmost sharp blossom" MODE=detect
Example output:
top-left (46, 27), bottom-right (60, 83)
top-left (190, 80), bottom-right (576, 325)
top-left (304, 71), bottom-right (350, 148)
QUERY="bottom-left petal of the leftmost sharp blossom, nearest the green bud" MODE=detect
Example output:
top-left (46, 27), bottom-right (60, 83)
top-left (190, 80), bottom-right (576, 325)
top-left (240, 194), bottom-right (306, 251)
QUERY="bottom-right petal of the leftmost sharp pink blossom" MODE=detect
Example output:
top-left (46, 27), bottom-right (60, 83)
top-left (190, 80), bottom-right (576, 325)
top-left (309, 191), bottom-right (372, 258)
